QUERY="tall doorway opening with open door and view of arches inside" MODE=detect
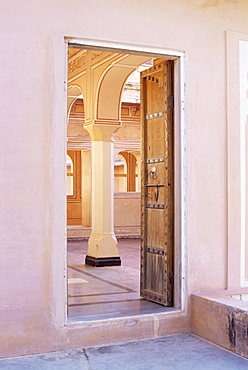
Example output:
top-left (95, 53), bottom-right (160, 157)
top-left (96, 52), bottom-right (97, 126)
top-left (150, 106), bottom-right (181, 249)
top-left (67, 43), bottom-right (184, 321)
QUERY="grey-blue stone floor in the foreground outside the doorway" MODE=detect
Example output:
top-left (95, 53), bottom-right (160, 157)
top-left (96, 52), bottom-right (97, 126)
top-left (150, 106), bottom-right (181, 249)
top-left (0, 334), bottom-right (248, 370)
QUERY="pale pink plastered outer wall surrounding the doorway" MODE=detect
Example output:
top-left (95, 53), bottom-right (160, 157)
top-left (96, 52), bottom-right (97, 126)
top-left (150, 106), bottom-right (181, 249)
top-left (0, 0), bottom-right (248, 356)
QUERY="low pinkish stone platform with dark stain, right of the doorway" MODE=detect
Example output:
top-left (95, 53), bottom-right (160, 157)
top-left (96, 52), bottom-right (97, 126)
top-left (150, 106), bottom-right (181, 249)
top-left (191, 288), bottom-right (248, 358)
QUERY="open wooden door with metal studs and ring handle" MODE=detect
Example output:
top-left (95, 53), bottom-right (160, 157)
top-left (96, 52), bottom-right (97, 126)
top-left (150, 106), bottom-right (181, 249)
top-left (140, 61), bottom-right (174, 306)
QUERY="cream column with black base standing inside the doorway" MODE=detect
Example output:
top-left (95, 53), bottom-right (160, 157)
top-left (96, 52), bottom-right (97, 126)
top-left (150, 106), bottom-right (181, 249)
top-left (85, 125), bottom-right (121, 267)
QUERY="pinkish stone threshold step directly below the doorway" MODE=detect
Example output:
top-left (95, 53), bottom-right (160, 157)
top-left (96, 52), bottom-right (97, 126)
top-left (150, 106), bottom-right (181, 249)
top-left (65, 309), bottom-right (190, 348)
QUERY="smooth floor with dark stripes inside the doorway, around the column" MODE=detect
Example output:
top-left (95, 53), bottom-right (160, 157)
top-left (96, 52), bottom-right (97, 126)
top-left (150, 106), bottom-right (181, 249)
top-left (68, 239), bottom-right (174, 321)
